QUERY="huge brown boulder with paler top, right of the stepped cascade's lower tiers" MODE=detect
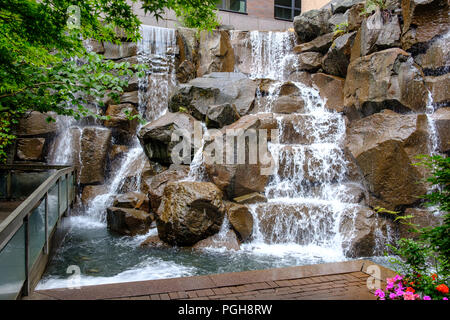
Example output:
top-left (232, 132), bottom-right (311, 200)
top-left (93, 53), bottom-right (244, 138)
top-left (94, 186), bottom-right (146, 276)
top-left (346, 110), bottom-right (430, 210)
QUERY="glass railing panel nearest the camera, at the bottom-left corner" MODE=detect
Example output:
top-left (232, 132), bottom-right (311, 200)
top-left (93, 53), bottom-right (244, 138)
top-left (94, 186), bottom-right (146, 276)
top-left (0, 225), bottom-right (26, 300)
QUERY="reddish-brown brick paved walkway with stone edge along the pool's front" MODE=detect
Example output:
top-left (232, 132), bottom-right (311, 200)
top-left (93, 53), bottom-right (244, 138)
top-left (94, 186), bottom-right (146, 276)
top-left (26, 260), bottom-right (394, 300)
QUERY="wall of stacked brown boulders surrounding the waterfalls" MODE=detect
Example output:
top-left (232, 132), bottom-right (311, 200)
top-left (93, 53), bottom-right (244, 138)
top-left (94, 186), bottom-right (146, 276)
top-left (15, 0), bottom-right (450, 256)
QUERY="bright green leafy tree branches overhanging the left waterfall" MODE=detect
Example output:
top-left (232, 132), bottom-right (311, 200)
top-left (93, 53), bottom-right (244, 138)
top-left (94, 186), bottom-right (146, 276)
top-left (0, 0), bottom-right (216, 162)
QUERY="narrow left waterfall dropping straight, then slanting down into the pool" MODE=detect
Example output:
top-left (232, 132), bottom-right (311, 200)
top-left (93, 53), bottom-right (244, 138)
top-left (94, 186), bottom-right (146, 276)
top-left (82, 25), bottom-right (176, 222)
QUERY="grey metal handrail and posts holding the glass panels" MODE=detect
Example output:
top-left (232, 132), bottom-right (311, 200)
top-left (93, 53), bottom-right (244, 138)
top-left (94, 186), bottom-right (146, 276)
top-left (0, 164), bottom-right (76, 295)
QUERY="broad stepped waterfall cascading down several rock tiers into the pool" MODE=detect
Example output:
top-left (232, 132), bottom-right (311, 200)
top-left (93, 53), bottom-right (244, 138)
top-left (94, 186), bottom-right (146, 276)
top-left (229, 31), bottom-right (358, 261)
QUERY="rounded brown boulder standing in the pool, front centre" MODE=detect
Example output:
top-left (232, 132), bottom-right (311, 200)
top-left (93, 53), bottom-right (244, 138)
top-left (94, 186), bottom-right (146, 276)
top-left (156, 181), bottom-right (225, 246)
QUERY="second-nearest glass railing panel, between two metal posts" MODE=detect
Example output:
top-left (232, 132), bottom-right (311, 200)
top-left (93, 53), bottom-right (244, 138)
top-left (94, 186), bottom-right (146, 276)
top-left (28, 199), bottom-right (45, 267)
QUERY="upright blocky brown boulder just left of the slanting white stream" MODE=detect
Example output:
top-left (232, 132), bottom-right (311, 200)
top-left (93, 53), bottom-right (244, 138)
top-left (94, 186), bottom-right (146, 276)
top-left (79, 127), bottom-right (111, 184)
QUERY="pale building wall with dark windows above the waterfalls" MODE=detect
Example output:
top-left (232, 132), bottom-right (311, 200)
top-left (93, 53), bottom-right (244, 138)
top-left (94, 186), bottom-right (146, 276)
top-left (133, 0), bottom-right (329, 31)
